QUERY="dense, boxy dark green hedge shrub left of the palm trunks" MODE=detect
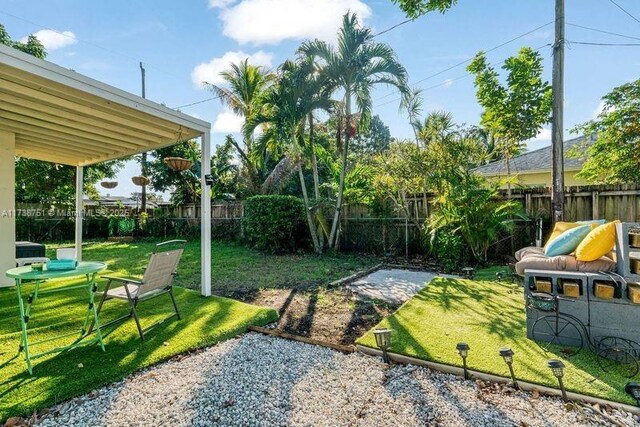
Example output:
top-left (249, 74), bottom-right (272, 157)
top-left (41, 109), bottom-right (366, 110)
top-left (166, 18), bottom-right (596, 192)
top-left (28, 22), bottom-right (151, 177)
top-left (242, 195), bottom-right (308, 253)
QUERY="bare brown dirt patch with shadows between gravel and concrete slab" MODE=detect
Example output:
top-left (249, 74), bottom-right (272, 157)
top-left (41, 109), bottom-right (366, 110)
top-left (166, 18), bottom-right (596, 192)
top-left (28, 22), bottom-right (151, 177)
top-left (228, 287), bottom-right (398, 345)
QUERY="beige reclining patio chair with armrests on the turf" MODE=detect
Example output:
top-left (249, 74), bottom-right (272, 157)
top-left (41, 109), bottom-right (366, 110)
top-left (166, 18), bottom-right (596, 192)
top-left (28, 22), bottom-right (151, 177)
top-left (89, 240), bottom-right (187, 341)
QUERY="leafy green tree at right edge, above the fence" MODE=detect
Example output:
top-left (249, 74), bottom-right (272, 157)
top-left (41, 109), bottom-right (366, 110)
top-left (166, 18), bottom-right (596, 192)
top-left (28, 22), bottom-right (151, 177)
top-left (567, 79), bottom-right (640, 184)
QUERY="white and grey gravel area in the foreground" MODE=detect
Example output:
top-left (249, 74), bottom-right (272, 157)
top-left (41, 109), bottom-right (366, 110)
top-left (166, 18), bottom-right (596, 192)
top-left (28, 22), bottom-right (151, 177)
top-left (38, 333), bottom-right (640, 427)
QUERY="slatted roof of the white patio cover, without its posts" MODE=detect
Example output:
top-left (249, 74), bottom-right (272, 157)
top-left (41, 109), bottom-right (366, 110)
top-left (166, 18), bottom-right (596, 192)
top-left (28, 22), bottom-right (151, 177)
top-left (0, 45), bottom-right (211, 166)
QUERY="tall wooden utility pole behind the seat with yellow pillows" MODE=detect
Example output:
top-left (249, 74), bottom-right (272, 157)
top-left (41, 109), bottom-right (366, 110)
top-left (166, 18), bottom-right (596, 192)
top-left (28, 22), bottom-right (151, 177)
top-left (551, 0), bottom-right (564, 223)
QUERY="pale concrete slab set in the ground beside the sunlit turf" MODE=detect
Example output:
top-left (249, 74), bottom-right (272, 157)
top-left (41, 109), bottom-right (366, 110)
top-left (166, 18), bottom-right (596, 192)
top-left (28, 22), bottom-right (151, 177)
top-left (347, 268), bottom-right (458, 304)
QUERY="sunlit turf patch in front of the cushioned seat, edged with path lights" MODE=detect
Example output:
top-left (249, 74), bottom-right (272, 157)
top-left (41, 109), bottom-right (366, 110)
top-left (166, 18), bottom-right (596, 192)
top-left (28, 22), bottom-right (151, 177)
top-left (357, 270), bottom-right (634, 404)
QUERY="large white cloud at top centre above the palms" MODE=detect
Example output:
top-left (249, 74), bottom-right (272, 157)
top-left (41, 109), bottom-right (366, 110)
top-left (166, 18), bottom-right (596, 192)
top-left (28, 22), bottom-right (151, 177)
top-left (219, 0), bottom-right (371, 45)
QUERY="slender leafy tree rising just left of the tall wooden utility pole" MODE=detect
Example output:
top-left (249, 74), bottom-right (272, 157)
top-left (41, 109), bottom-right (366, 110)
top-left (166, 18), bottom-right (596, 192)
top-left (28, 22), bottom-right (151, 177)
top-left (468, 47), bottom-right (551, 197)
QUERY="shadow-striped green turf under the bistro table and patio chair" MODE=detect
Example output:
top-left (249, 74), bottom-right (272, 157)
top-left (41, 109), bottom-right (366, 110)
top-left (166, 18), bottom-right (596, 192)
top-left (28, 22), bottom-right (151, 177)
top-left (0, 270), bottom-right (278, 421)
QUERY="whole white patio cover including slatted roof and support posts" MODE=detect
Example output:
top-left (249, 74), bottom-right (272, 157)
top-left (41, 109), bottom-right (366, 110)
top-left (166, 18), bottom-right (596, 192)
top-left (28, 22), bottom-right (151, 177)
top-left (0, 44), bottom-right (211, 295)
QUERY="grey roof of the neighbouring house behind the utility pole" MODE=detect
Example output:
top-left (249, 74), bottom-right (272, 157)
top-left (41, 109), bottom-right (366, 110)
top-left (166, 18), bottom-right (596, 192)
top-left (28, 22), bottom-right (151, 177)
top-left (473, 136), bottom-right (590, 176)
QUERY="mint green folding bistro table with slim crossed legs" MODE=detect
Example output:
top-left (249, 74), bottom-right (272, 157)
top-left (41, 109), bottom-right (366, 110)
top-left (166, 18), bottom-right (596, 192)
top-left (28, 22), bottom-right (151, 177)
top-left (6, 262), bottom-right (107, 374)
